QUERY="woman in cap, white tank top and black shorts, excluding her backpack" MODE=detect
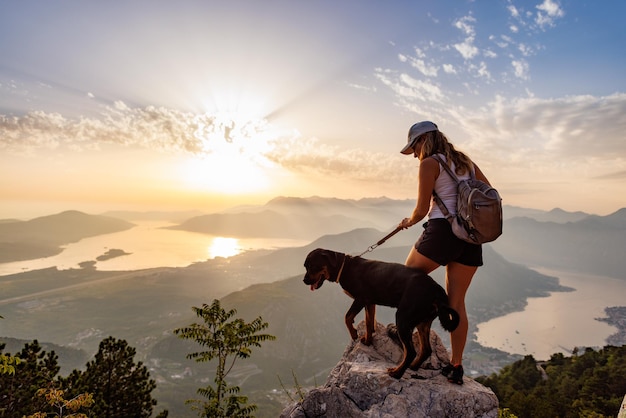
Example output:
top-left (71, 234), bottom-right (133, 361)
top-left (399, 121), bottom-right (489, 385)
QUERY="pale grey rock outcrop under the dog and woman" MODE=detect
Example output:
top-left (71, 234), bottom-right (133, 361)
top-left (280, 322), bottom-right (498, 418)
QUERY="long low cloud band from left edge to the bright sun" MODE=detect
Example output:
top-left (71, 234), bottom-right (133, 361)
top-left (0, 101), bottom-right (282, 154)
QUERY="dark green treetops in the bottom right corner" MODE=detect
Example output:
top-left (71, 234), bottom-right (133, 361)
top-left (476, 346), bottom-right (626, 418)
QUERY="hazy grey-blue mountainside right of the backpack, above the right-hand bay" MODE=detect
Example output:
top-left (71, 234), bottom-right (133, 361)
top-left (492, 209), bottom-right (626, 279)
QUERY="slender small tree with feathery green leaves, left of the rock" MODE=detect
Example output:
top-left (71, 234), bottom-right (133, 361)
top-left (174, 299), bottom-right (276, 418)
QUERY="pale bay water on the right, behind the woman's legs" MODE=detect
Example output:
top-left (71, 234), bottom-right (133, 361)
top-left (476, 267), bottom-right (626, 360)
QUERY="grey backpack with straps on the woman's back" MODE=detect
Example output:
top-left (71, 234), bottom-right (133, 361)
top-left (433, 155), bottom-right (502, 244)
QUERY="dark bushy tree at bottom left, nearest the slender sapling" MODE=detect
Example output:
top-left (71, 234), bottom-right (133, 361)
top-left (63, 337), bottom-right (157, 418)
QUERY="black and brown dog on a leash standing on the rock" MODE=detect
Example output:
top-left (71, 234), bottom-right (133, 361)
top-left (304, 248), bottom-right (459, 379)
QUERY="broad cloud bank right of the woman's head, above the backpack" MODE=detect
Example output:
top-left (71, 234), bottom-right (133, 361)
top-left (457, 93), bottom-right (626, 166)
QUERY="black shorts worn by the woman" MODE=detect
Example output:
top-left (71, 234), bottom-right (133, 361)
top-left (415, 218), bottom-right (483, 267)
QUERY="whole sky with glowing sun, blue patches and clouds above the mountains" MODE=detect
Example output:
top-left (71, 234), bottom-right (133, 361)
top-left (0, 0), bottom-right (626, 219)
